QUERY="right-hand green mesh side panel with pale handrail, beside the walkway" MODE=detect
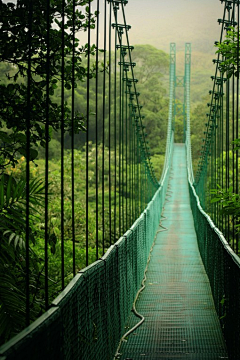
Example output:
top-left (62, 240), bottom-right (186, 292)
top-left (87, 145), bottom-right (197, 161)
top-left (189, 183), bottom-right (240, 360)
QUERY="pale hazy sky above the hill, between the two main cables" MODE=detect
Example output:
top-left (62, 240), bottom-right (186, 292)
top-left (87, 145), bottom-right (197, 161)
top-left (125, 0), bottom-right (224, 52)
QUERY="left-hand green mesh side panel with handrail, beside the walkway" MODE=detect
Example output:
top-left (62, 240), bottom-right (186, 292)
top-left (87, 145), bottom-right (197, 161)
top-left (0, 164), bottom-right (172, 360)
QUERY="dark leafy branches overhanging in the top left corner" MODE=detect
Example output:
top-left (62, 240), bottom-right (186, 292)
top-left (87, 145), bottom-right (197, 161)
top-left (0, 0), bottom-right (98, 168)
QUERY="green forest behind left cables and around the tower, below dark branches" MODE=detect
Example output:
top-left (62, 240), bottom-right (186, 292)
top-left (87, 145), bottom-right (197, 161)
top-left (0, 33), bottom-right (216, 341)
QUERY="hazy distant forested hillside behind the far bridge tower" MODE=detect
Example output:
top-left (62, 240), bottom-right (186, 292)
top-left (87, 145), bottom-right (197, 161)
top-left (0, 45), bottom-right (213, 176)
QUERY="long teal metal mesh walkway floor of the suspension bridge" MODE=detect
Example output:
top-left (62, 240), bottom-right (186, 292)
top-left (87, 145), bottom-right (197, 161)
top-left (121, 144), bottom-right (228, 360)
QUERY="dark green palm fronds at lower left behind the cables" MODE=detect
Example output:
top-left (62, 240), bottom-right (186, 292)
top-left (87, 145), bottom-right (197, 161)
top-left (0, 174), bottom-right (46, 343)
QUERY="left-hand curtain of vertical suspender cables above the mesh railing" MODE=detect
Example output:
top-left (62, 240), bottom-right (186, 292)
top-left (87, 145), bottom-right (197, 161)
top-left (0, 0), bottom-right (162, 344)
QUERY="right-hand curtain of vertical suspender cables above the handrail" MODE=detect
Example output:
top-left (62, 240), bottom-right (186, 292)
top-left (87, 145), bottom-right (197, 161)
top-left (194, 0), bottom-right (240, 254)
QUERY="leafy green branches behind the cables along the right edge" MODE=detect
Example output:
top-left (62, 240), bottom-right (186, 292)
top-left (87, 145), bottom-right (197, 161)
top-left (211, 26), bottom-right (240, 245)
